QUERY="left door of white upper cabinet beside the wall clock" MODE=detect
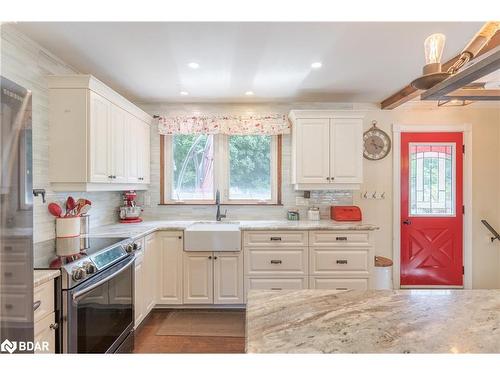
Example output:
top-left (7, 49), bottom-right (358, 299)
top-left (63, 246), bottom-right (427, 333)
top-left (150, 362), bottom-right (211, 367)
top-left (295, 119), bottom-right (330, 184)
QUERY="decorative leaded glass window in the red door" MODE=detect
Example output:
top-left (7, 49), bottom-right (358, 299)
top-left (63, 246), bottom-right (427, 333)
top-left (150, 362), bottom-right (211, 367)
top-left (408, 143), bottom-right (456, 216)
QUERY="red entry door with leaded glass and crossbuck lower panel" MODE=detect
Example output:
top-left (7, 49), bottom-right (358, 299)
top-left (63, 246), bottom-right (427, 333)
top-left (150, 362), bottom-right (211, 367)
top-left (400, 133), bottom-right (463, 287)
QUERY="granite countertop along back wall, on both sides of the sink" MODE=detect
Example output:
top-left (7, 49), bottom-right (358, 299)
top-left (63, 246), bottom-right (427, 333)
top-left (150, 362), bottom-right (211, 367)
top-left (90, 220), bottom-right (379, 238)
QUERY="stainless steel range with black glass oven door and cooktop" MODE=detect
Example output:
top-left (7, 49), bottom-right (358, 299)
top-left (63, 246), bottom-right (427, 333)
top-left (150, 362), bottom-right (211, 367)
top-left (35, 237), bottom-right (140, 353)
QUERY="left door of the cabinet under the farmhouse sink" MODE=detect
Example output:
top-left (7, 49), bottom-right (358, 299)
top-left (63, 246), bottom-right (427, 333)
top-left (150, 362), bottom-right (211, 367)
top-left (183, 251), bottom-right (214, 304)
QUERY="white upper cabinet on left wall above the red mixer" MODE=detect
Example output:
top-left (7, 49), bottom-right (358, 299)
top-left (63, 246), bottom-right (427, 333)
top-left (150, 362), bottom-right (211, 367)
top-left (48, 75), bottom-right (151, 191)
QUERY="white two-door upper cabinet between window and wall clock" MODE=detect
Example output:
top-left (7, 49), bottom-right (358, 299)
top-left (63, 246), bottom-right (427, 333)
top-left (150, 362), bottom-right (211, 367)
top-left (289, 110), bottom-right (363, 190)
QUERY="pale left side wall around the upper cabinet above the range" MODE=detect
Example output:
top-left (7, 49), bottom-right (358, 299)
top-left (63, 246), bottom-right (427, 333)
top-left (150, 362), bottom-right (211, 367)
top-left (0, 25), bottom-right (121, 242)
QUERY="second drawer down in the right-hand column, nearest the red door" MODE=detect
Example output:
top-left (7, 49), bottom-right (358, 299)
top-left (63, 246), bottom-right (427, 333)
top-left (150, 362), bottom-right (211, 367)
top-left (310, 248), bottom-right (369, 275)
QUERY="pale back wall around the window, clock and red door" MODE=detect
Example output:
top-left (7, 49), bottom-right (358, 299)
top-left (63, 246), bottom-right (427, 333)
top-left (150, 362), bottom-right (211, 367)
top-left (140, 103), bottom-right (500, 288)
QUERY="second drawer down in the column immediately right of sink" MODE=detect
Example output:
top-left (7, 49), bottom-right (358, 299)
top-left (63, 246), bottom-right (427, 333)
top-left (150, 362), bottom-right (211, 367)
top-left (245, 247), bottom-right (307, 276)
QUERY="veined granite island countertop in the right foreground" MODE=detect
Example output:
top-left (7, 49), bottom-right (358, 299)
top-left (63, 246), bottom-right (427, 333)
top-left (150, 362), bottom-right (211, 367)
top-left (246, 290), bottom-right (500, 353)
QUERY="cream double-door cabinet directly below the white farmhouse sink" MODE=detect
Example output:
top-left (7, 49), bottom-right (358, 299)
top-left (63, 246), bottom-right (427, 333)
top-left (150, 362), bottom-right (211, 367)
top-left (183, 251), bottom-right (243, 304)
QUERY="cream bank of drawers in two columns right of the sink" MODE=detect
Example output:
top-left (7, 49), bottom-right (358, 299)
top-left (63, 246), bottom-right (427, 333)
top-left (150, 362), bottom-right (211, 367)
top-left (243, 230), bottom-right (374, 292)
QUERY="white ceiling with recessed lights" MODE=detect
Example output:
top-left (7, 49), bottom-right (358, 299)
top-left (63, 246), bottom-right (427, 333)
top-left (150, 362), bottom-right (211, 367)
top-left (16, 22), bottom-right (482, 102)
